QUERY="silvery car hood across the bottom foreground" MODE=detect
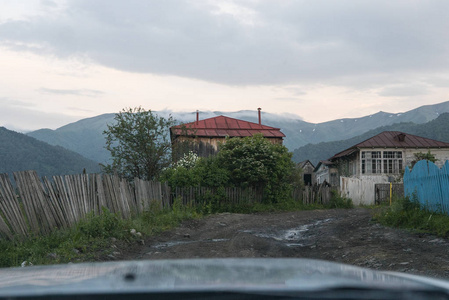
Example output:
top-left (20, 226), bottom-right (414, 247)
top-left (0, 259), bottom-right (449, 298)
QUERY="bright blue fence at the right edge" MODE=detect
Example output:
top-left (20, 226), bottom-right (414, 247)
top-left (404, 160), bottom-right (449, 214)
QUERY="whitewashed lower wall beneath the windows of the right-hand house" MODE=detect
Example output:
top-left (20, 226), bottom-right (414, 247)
top-left (340, 175), bottom-right (388, 205)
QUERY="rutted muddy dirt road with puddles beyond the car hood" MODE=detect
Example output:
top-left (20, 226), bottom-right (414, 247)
top-left (120, 208), bottom-right (449, 279)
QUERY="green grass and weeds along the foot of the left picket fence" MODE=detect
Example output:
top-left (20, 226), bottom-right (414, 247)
top-left (0, 203), bottom-right (201, 267)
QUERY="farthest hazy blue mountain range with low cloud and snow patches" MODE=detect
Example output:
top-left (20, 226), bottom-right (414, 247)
top-left (28, 101), bottom-right (449, 163)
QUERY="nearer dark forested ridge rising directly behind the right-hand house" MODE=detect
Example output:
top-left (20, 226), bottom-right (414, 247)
top-left (293, 113), bottom-right (449, 165)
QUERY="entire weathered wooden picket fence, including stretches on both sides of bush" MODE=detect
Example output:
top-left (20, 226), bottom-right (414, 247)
top-left (0, 171), bottom-right (338, 239)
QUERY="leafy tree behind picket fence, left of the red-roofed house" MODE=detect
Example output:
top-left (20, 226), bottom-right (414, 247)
top-left (102, 107), bottom-right (175, 180)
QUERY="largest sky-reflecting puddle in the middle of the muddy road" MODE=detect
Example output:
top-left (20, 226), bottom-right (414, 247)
top-left (242, 219), bottom-right (332, 247)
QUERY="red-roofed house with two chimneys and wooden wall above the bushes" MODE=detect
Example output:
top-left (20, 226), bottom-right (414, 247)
top-left (170, 109), bottom-right (285, 156)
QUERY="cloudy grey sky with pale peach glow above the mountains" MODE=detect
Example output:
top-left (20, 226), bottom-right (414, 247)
top-left (0, 0), bottom-right (449, 130)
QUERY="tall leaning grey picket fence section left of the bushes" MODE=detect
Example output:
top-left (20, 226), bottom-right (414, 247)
top-left (0, 171), bottom-right (170, 238)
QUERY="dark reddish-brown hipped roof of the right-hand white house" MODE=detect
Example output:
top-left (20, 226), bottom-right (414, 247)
top-left (330, 131), bottom-right (449, 160)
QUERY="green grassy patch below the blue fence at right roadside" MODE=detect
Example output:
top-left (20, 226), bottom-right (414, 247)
top-left (373, 198), bottom-right (449, 237)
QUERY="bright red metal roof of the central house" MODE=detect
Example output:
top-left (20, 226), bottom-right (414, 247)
top-left (170, 116), bottom-right (285, 138)
